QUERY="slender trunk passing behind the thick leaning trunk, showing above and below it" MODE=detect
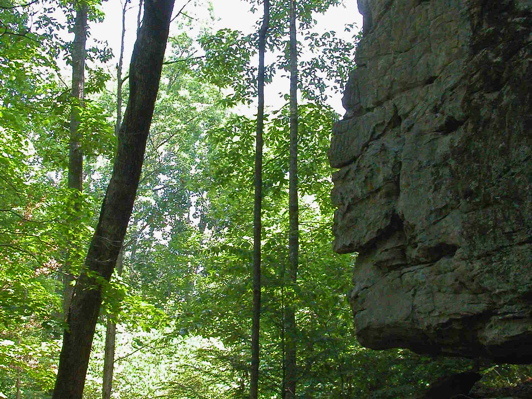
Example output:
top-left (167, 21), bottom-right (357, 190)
top-left (102, 0), bottom-right (130, 399)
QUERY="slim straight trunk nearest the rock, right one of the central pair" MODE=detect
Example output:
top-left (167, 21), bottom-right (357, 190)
top-left (284, 0), bottom-right (299, 398)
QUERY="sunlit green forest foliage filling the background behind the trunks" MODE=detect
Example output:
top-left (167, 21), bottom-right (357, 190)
top-left (0, 0), bottom-right (525, 399)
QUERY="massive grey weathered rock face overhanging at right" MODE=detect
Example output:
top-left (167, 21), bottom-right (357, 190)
top-left (329, 0), bottom-right (532, 363)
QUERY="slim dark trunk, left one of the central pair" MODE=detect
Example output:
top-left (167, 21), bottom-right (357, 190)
top-left (250, 0), bottom-right (270, 399)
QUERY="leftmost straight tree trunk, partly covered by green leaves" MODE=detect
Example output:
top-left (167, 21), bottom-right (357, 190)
top-left (63, 2), bottom-right (87, 319)
